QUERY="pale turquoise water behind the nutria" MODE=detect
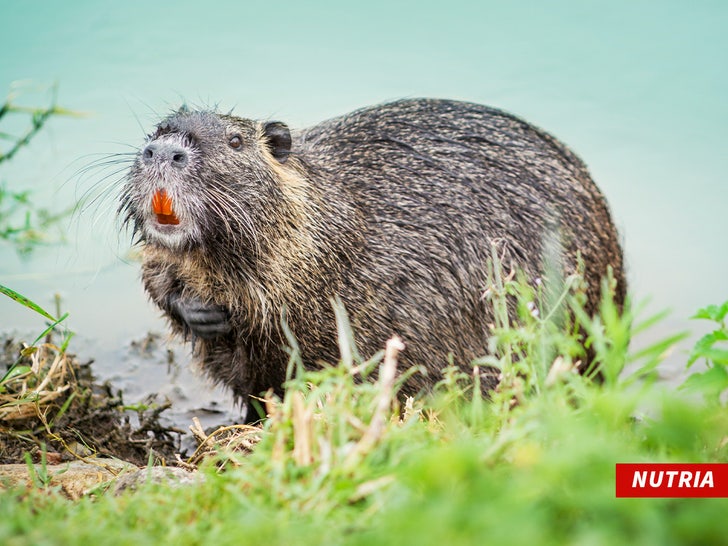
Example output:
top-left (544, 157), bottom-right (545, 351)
top-left (0, 0), bottom-right (728, 404)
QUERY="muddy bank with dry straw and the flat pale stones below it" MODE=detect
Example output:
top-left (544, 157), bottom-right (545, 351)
top-left (0, 336), bottom-right (260, 492)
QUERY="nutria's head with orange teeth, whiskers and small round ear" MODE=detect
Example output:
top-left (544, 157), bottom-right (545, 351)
top-left (119, 108), bottom-right (291, 253)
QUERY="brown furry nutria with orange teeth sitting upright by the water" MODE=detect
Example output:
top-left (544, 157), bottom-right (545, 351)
top-left (120, 99), bottom-right (625, 416)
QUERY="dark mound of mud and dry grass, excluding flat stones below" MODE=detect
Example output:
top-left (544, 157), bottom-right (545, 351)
top-left (0, 338), bottom-right (187, 465)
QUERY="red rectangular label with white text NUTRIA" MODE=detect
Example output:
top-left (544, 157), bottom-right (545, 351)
top-left (616, 463), bottom-right (728, 498)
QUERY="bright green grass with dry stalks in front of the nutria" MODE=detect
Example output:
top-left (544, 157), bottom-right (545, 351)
top-left (0, 262), bottom-right (728, 546)
